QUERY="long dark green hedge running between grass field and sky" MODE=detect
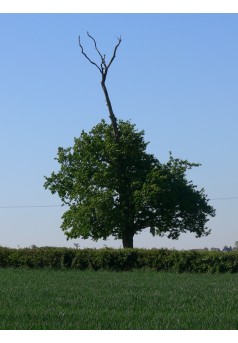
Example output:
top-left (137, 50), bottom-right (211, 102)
top-left (0, 247), bottom-right (238, 273)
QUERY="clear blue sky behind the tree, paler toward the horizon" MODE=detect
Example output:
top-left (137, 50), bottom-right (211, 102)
top-left (0, 14), bottom-right (238, 249)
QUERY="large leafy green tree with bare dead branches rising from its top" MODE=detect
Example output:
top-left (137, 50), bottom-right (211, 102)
top-left (44, 34), bottom-right (215, 248)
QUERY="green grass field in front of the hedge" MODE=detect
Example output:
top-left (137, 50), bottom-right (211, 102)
top-left (0, 269), bottom-right (238, 330)
